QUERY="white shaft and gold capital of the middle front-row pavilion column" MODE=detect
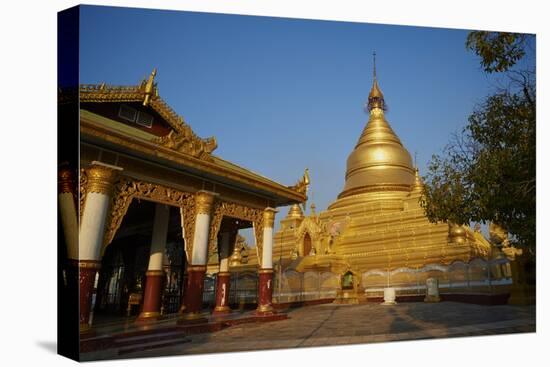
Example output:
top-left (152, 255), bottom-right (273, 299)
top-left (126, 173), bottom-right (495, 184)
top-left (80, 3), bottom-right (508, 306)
top-left (191, 191), bottom-right (216, 265)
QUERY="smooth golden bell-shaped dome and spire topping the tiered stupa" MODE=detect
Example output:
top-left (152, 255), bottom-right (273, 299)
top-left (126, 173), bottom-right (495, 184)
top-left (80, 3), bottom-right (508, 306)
top-left (338, 79), bottom-right (415, 198)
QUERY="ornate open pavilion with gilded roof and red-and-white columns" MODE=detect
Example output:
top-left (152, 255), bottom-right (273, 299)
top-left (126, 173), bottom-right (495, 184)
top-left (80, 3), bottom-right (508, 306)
top-left (58, 70), bottom-right (307, 332)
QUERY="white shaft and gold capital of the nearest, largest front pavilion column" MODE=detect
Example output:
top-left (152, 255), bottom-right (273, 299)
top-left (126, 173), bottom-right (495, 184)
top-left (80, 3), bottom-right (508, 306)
top-left (79, 161), bottom-right (122, 261)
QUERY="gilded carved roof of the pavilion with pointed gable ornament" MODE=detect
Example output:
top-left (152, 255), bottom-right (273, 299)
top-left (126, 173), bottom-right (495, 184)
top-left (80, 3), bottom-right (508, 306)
top-left (71, 70), bottom-right (307, 205)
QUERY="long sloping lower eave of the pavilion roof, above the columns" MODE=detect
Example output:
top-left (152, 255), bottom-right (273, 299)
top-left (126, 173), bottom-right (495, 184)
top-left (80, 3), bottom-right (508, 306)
top-left (80, 116), bottom-right (307, 205)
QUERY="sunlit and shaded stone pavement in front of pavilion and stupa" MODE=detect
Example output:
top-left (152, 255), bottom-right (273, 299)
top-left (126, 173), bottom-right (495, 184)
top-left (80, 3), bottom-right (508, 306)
top-left (88, 302), bottom-right (536, 359)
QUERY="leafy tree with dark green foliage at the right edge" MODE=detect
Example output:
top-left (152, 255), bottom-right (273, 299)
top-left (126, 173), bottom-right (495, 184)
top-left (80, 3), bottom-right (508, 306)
top-left (421, 32), bottom-right (536, 249)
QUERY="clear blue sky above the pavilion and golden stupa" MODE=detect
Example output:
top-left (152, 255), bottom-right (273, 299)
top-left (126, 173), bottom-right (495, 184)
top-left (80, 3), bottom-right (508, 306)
top-left (80, 6), bottom-right (532, 229)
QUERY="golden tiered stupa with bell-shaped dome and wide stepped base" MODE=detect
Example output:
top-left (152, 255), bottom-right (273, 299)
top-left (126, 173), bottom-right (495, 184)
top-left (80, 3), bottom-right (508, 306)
top-left (273, 61), bottom-right (491, 302)
